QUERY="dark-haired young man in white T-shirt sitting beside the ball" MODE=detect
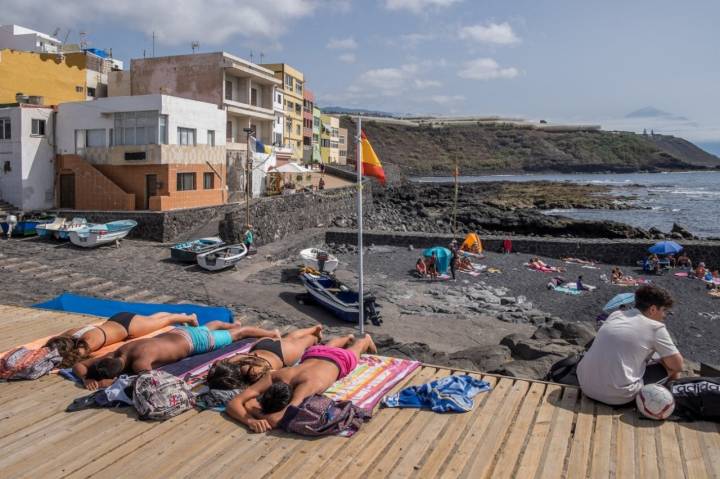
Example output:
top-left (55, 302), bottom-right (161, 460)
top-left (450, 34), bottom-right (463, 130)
top-left (577, 286), bottom-right (683, 405)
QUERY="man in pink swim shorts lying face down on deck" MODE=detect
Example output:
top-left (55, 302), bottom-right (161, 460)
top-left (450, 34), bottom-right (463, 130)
top-left (226, 334), bottom-right (377, 432)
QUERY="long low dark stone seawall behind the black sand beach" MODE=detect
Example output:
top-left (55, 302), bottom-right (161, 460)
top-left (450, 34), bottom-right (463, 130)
top-left (325, 228), bottom-right (720, 269)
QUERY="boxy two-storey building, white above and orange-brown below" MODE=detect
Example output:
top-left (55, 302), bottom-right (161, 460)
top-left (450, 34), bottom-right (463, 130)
top-left (55, 94), bottom-right (227, 211)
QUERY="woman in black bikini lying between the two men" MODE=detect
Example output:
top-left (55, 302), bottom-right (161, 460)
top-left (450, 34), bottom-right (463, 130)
top-left (207, 325), bottom-right (322, 390)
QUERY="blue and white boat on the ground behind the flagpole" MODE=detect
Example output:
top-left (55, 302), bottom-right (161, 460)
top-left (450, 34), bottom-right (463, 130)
top-left (299, 272), bottom-right (382, 326)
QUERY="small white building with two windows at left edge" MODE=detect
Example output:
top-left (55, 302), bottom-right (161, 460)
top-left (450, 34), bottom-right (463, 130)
top-left (0, 104), bottom-right (55, 211)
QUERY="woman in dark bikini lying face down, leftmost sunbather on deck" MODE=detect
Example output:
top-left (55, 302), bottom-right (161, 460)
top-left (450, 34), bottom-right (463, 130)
top-left (45, 312), bottom-right (198, 368)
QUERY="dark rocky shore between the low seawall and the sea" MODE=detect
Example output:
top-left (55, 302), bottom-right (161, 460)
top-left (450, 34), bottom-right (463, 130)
top-left (333, 182), bottom-right (694, 239)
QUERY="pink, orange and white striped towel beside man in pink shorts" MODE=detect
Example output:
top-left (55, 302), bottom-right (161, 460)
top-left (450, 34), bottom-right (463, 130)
top-left (325, 354), bottom-right (420, 409)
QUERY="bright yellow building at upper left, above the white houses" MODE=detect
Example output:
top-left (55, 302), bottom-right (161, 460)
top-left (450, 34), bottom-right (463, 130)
top-left (0, 50), bottom-right (87, 105)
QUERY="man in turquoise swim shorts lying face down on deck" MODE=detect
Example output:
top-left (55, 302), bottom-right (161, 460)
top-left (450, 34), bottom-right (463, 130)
top-left (73, 321), bottom-right (279, 390)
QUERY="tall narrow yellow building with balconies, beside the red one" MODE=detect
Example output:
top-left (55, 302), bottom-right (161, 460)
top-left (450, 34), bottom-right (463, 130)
top-left (260, 63), bottom-right (305, 161)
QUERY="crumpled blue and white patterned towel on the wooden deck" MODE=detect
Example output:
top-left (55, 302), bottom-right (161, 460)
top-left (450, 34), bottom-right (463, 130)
top-left (382, 376), bottom-right (490, 412)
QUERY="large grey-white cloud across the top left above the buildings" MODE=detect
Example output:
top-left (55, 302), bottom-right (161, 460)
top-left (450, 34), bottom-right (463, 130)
top-left (2, 0), bottom-right (320, 46)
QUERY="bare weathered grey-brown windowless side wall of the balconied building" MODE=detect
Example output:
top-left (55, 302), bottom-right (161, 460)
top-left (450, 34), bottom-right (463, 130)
top-left (130, 53), bottom-right (223, 105)
